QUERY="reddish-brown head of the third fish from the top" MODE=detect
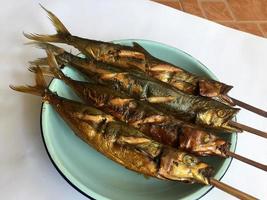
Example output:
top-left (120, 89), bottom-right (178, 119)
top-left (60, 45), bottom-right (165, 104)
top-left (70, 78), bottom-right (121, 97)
top-left (179, 127), bottom-right (230, 157)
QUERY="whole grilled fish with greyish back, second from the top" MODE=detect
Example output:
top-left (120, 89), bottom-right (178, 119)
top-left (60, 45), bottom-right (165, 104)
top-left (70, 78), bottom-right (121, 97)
top-left (31, 43), bottom-right (240, 132)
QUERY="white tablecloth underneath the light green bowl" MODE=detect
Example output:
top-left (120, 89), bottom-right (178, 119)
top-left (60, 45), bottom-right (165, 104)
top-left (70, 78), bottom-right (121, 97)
top-left (0, 0), bottom-right (267, 200)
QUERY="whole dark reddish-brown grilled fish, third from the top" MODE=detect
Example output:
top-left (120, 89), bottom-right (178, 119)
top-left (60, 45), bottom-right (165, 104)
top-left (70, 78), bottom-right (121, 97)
top-left (29, 51), bottom-right (229, 157)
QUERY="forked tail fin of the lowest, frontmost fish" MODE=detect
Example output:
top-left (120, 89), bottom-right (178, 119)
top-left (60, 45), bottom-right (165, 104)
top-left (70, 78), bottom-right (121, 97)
top-left (9, 67), bottom-right (47, 97)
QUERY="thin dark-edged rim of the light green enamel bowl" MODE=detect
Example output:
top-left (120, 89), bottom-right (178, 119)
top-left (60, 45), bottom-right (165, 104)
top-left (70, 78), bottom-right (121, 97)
top-left (40, 39), bottom-right (238, 200)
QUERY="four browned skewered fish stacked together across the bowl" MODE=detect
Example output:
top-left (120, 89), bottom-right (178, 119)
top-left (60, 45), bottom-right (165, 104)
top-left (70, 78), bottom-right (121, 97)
top-left (11, 5), bottom-right (266, 198)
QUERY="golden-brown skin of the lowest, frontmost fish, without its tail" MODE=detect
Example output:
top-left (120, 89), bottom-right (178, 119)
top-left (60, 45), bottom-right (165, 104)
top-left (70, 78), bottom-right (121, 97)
top-left (48, 94), bottom-right (213, 183)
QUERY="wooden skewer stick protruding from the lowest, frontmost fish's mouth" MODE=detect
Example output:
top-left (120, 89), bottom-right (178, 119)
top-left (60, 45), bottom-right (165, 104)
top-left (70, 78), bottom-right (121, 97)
top-left (210, 178), bottom-right (257, 200)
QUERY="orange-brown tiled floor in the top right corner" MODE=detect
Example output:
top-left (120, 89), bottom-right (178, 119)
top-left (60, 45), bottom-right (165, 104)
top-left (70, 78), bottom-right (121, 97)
top-left (155, 0), bottom-right (267, 37)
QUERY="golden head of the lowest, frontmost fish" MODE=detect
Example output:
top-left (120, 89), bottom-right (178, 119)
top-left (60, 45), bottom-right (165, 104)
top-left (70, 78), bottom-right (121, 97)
top-left (159, 148), bottom-right (213, 184)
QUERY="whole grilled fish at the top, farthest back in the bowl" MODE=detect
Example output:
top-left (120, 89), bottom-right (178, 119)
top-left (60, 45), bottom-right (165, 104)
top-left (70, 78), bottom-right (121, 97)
top-left (25, 7), bottom-right (233, 104)
